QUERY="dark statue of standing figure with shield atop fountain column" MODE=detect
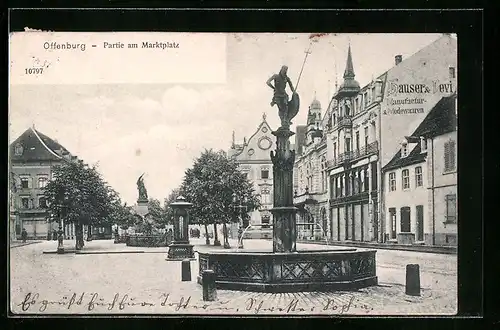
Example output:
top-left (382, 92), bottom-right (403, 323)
top-left (266, 65), bottom-right (300, 128)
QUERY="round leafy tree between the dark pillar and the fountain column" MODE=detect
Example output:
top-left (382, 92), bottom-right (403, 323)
top-left (182, 150), bottom-right (260, 248)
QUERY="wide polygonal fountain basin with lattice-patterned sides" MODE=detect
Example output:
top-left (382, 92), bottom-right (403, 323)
top-left (197, 248), bottom-right (378, 293)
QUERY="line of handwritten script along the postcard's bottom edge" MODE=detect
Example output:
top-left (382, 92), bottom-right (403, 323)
top-left (17, 292), bottom-right (373, 314)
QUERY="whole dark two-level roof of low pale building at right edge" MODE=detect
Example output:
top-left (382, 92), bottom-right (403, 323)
top-left (382, 94), bottom-right (457, 171)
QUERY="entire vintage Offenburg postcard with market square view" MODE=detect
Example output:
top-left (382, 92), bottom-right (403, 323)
top-left (8, 30), bottom-right (459, 316)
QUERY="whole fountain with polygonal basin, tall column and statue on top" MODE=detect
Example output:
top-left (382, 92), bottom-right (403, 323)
top-left (197, 67), bottom-right (378, 292)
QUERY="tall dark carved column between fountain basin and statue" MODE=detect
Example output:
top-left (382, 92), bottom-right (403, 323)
top-left (271, 126), bottom-right (298, 252)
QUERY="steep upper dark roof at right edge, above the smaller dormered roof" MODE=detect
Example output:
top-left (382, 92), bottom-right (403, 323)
top-left (412, 94), bottom-right (457, 138)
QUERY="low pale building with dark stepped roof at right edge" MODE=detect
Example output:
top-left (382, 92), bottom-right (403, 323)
top-left (383, 94), bottom-right (458, 245)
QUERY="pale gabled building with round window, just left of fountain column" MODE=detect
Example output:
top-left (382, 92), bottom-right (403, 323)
top-left (228, 114), bottom-right (275, 238)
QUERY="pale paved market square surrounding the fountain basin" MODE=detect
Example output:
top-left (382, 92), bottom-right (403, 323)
top-left (10, 239), bottom-right (457, 315)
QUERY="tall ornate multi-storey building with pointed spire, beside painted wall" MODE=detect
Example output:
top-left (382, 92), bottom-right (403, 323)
top-left (327, 46), bottom-right (384, 241)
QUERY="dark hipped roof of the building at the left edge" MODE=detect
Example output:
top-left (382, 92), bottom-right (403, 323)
top-left (10, 127), bottom-right (69, 162)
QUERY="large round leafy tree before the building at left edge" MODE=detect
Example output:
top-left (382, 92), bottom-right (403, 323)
top-left (44, 161), bottom-right (118, 249)
